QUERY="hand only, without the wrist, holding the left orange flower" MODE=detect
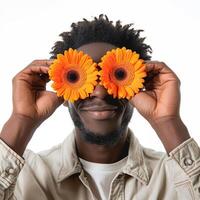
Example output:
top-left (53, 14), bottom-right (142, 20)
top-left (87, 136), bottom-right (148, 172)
top-left (13, 60), bottom-right (63, 124)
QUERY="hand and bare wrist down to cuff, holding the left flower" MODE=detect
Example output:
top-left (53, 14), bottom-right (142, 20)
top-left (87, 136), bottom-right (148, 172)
top-left (0, 60), bottom-right (63, 155)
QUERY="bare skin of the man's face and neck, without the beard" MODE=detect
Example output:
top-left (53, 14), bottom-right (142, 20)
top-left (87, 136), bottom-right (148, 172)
top-left (69, 43), bottom-right (132, 163)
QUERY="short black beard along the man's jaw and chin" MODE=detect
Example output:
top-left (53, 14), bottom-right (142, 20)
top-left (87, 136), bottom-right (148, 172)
top-left (68, 100), bottom-right (133, 145)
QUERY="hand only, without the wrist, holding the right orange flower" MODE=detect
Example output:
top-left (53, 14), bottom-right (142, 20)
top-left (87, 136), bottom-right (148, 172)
top-left (130, 61), bottom-right (180, 123)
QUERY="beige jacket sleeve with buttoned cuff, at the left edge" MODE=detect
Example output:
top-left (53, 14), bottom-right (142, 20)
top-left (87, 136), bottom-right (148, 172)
top-left (0, 139), bottom-right (25, 200)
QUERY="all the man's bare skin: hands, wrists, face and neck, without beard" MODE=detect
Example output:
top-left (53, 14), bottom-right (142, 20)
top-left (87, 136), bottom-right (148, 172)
top-left (0, 43), bottom-right (190, 163)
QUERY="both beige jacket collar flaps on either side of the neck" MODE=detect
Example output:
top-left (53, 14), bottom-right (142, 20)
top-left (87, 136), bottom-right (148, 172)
top-left (56, 129), bottom-right (151, 184)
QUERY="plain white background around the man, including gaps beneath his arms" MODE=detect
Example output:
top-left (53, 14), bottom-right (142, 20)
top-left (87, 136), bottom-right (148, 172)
top-left (0, 0), bottom-right (200, 152)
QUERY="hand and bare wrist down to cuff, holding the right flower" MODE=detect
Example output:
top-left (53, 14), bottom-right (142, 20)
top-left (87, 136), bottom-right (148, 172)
top-left (130, 61), bottom-right (190, 153)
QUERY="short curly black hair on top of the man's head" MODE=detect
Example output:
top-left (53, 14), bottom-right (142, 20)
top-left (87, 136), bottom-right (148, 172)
top-left (50, 14), bottom-right (152, 60)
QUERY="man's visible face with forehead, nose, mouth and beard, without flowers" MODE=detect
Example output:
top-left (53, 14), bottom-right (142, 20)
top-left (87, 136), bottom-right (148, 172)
top-left (68, 43), bottom-right (133, 145)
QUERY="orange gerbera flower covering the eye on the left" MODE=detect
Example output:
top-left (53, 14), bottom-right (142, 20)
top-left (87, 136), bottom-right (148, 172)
top-left (49, 48), bottom-right (98, 102)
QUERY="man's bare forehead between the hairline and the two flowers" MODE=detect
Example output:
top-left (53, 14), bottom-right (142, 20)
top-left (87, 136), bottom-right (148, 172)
top-left (77, 42), bottom-right (117, 62)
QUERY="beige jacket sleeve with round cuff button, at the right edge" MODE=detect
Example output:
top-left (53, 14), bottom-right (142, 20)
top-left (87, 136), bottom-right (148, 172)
top-left (169, 138), bottom-right (200, 200)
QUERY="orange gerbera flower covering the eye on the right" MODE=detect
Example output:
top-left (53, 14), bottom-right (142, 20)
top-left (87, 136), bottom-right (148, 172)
top-left (99, 47), bottom-right (147, 99)
